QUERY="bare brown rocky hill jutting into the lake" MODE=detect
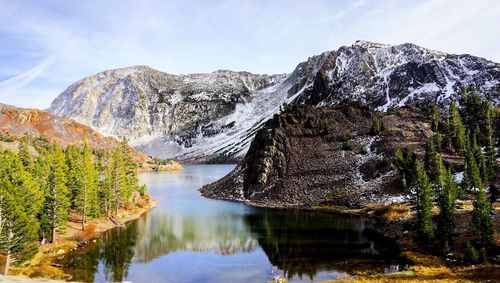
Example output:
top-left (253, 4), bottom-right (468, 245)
top-left (201, 105), bottom-right (432, 207)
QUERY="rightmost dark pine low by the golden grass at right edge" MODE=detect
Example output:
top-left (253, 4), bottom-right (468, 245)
top-left (471, 186), bottom-right (493, 248)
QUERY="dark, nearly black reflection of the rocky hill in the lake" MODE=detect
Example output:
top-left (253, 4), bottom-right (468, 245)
top-left (246, 210), bottom-right (397, 279)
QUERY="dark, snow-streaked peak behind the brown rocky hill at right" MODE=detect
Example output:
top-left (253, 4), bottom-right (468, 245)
top-left (294, 41), bottom-right (500, 111)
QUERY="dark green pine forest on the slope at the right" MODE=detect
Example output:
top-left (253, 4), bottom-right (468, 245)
top-left (395, 90), bottom-right (498, 262)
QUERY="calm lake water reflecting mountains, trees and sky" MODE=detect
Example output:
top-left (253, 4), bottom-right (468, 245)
top-left (61, 165), bottom-right (397, 282)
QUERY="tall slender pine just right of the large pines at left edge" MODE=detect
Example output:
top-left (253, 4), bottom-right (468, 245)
top-left (45, 146), bottom-right (71, 242)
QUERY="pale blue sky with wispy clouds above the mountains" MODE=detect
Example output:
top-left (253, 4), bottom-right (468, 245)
top-left (0, 0), bottom-right (500, 109)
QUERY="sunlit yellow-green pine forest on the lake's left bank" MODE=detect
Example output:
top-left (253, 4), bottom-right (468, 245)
top-left (0, 135), bottom-right (146, 274)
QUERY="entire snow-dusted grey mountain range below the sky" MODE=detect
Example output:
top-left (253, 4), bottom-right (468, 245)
top-left (48, 41), bottom-right (500, 162)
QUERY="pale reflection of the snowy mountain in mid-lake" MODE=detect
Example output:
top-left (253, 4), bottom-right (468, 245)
top-left (134, 214), bottom-right (258, 263)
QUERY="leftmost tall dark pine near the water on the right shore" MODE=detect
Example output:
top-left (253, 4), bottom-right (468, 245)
top-left (415, 159), bottom-right (434, 240)
